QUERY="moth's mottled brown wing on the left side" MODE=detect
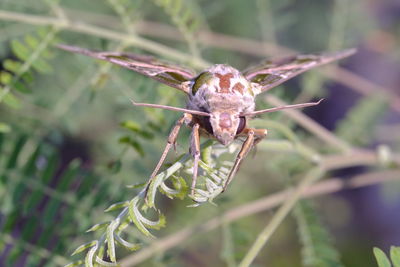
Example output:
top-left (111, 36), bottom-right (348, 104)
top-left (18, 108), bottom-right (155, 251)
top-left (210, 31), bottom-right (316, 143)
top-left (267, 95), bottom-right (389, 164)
top-left (57, 45), bottom-right (195, 93)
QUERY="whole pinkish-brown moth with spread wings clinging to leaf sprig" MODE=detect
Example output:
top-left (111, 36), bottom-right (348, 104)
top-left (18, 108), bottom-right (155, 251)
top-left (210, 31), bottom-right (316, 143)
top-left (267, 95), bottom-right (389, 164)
top-left (58, 45), bottom-right (355, 195)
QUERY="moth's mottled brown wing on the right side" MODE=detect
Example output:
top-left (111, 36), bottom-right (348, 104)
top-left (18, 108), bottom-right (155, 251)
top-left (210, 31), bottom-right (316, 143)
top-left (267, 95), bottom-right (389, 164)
top-left (243, 49), bottom-right (356, 92)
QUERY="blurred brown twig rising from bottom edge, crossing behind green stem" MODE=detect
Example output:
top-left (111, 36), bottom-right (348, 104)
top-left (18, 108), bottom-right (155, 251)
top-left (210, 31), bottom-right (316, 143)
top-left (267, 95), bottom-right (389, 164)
top-left (120, 170), bottom-right (400, 267)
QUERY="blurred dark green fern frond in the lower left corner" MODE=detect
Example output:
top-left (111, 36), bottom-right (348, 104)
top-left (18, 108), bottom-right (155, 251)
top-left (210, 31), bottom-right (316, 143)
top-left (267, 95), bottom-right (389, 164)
top-left (0, 134), bottom-right (114, 266)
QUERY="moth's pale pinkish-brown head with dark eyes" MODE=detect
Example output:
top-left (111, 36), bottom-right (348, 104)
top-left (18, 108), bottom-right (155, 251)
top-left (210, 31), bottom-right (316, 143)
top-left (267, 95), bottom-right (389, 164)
top-left (204, 111), bottom-right (246, 146)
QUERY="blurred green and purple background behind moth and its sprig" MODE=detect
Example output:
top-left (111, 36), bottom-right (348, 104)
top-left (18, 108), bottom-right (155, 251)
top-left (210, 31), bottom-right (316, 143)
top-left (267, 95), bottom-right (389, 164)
top-left (0, 0), bottom-right (400, 267)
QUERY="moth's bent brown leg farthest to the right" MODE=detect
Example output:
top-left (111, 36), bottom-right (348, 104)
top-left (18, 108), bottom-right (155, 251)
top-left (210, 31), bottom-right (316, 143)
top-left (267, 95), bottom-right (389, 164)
top-left (222, 128), bottom-right (267, 192)
